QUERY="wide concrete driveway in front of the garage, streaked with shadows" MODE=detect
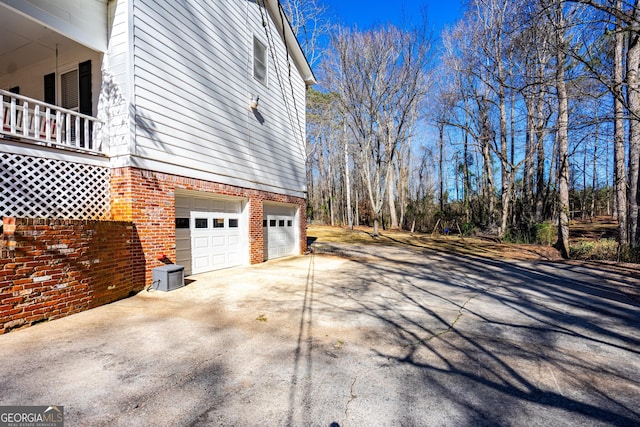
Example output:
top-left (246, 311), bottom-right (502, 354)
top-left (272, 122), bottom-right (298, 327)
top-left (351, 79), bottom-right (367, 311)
top-left (0, 244), bottom-right (640, 427)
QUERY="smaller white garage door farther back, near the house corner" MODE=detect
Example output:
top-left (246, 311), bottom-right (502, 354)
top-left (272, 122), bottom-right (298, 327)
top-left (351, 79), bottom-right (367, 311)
top-left (264, 203), bottom-right (299, 259)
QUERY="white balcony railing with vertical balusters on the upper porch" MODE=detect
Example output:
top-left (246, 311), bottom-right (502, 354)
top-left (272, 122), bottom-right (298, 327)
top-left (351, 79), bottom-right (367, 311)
top-left (0, 90), bottom-right (103, 154)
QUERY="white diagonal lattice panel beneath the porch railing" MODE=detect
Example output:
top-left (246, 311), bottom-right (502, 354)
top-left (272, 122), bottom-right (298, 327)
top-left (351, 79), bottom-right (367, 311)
top-left (0, 153), bottom-right (110, 220)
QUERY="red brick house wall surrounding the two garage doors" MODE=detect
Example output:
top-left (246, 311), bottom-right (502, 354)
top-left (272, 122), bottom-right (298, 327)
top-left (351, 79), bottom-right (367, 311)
top-left (111, 167), bottom-right (307, 284)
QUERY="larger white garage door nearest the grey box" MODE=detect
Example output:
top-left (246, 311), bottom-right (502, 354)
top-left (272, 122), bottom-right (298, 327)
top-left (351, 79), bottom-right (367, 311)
top-left (176, 197), bottom-right (246, 275)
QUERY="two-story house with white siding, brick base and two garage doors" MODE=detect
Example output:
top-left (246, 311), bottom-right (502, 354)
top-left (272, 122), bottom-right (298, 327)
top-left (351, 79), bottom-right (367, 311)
top-left (0, 0), bottom-right (315, 330)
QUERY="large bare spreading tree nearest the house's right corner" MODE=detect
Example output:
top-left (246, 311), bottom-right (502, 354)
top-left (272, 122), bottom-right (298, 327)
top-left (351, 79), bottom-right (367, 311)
top-left (325, 26), bottom-right (431, 235)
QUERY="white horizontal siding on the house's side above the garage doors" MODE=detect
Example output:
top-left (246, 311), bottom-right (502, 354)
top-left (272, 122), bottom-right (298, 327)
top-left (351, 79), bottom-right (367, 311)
top-left (133, 0), bottom-right (305, 196)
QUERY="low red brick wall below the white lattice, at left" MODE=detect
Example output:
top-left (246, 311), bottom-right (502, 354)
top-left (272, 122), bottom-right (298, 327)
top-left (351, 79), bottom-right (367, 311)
top-left (0, 217), bottom-right (145, 333)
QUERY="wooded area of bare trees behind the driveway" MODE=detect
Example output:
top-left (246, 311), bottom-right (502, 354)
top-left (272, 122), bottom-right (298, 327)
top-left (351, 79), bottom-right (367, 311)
top-left (290, 0), bottom-right (640, 260)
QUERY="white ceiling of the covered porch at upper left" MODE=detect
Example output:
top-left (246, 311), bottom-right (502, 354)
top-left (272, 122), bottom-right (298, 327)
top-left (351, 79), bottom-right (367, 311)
top-left (0, 3), bottom-right (84, 79)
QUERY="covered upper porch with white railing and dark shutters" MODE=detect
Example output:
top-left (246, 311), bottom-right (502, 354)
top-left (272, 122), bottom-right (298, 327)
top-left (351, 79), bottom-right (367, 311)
top-left (0, 0), bottom-right (108, 154)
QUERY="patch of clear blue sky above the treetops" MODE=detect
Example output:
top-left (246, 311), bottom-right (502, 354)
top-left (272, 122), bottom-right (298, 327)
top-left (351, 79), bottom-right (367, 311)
top-left (321, 0), bottom-right (463, 36)
